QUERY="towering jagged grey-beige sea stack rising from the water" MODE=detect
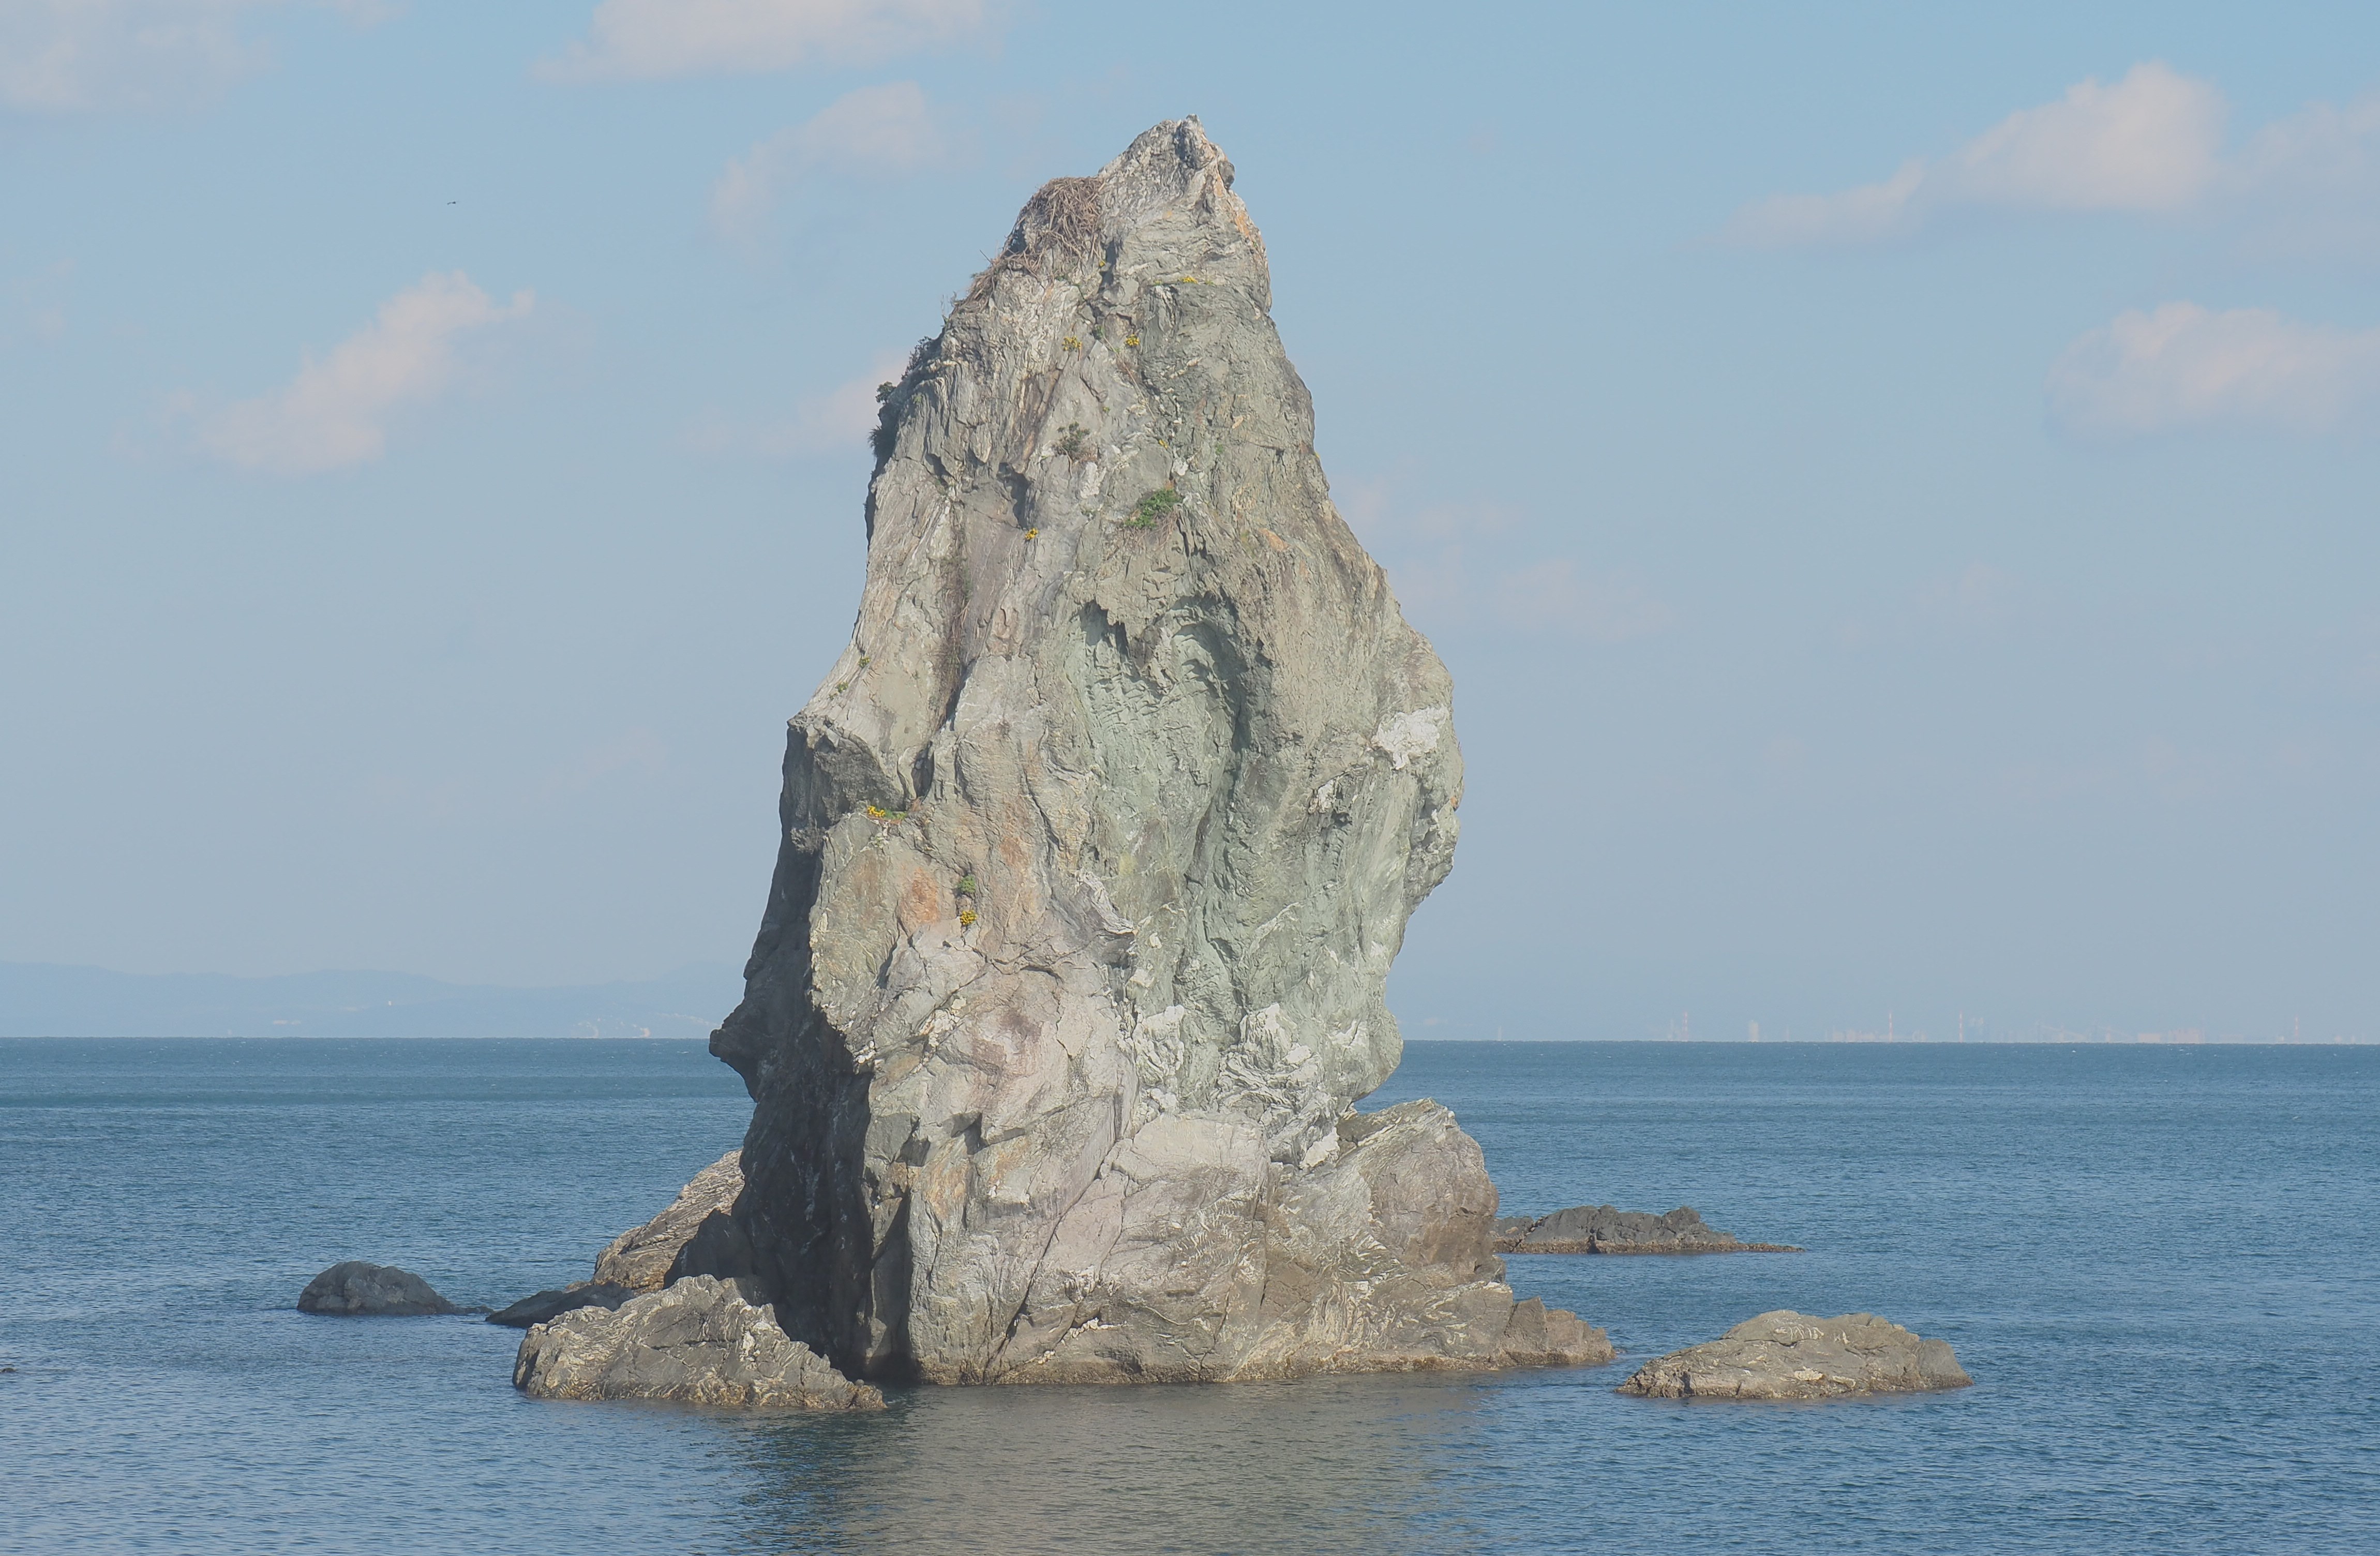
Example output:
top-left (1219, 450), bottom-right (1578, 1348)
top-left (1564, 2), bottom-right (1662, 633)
top-left (681, 119), bottom-right (1609, 1382)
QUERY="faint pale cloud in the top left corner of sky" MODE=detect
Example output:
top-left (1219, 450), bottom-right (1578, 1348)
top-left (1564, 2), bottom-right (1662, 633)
top-left (0, 0), bottom-right (383, 114)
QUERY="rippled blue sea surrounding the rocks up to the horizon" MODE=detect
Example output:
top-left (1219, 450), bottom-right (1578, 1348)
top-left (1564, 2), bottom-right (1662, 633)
top-left (0, 1040), bottom-right (2380, 1553)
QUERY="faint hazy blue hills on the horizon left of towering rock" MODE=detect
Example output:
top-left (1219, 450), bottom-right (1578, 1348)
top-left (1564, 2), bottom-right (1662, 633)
top-left (0, 961), bottom-right (743, 1037)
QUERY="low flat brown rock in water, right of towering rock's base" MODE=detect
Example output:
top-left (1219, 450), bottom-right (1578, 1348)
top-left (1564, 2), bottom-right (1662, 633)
top-left (1621, 1311), bottom-right (1975, 1399)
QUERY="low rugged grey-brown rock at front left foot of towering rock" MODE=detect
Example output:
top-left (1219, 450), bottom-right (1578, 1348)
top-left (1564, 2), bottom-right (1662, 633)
top-left (512, 1275), bottom-right (886, 1411)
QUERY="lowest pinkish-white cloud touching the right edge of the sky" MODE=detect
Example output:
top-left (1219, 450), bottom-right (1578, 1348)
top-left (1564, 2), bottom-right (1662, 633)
top-left (2049, 302), bottom-right (2380, 438)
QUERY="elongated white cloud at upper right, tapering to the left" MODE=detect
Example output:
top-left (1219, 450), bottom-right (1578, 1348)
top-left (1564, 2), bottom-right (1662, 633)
top-left (1728, 62), bottom-right (2228, 247)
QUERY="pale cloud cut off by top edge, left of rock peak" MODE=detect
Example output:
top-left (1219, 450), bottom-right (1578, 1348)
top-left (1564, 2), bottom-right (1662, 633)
top-left (538, 0), bottom-right (995, 81)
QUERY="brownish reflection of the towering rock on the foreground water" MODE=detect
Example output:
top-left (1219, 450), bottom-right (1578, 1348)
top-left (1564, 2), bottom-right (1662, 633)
top-left (731, 1370), bottom-right (1504, 1553)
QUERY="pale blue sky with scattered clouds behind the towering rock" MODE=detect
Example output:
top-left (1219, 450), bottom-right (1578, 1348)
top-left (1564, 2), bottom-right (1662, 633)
top-left (0, 0), bottom-right (2380, 1037)
